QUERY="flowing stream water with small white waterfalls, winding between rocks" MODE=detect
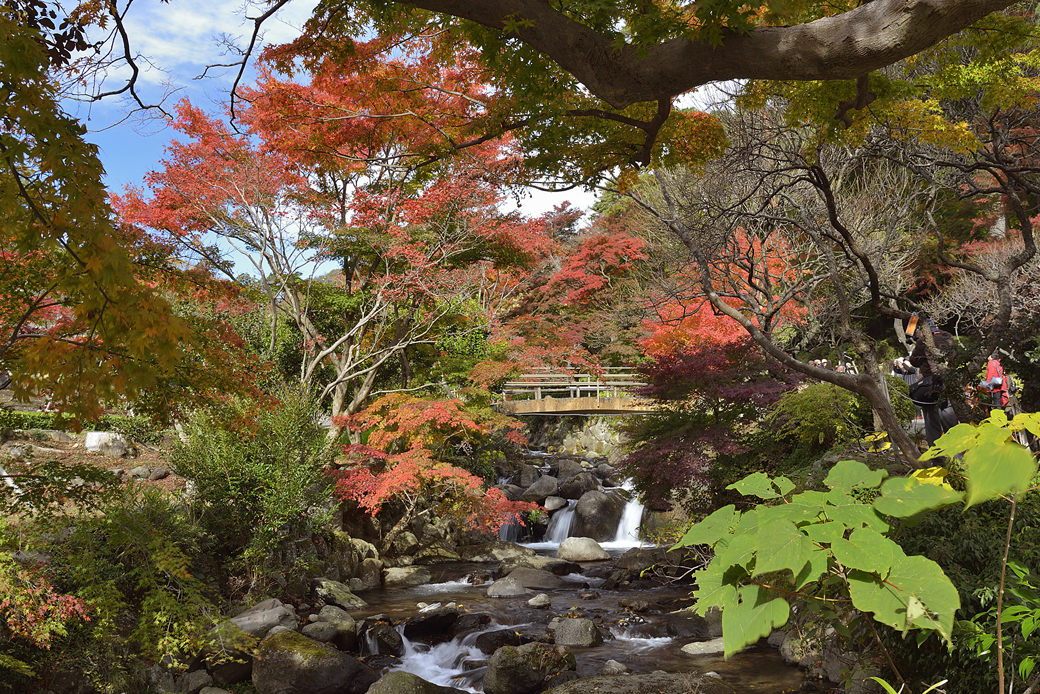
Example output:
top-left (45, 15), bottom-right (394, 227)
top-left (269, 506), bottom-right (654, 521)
top-left (352, 455), bottom-right (806, 694)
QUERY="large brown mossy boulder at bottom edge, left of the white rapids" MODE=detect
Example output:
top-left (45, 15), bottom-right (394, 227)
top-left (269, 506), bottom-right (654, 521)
top-left (253, 631), bottom-right (379, 694)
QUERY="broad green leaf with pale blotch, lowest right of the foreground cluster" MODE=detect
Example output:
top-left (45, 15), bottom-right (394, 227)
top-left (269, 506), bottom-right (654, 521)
top-left (849, 557), bottom-right (961, 643)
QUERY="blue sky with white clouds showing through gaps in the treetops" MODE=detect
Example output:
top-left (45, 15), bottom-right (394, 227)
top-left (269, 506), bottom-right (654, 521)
top-left (67, 0), bottom-right (593, 215)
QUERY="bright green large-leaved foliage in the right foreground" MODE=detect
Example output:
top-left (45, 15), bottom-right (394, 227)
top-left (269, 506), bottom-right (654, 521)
top-left (676, 411), bottom-right (1040, 677)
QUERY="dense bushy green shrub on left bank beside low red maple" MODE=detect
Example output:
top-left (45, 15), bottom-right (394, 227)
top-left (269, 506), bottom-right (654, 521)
top-left (171, 390), bottom-right (331, 590)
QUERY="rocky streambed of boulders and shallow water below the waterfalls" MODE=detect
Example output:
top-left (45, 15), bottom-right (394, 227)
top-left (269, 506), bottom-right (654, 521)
top-left (153, 542), bottom-right (806, 694)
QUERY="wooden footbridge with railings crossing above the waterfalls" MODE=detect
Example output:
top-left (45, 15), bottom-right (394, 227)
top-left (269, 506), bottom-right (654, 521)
top-left (495, 366), bottom-right (655, 415)
